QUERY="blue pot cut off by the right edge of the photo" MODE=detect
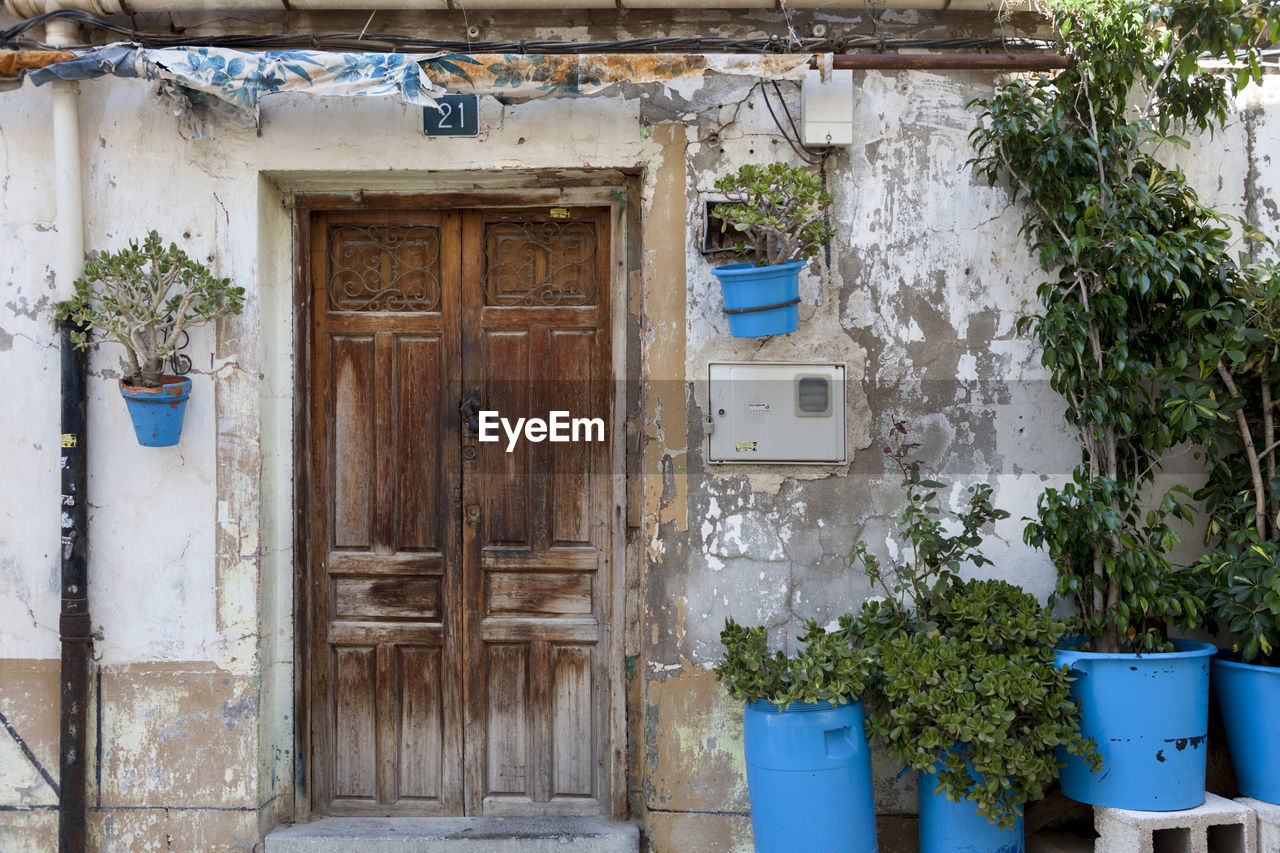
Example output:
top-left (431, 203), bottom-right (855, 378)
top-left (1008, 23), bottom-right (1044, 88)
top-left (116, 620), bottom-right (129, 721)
top-left (1213, 656), bottom-right (1280, 804)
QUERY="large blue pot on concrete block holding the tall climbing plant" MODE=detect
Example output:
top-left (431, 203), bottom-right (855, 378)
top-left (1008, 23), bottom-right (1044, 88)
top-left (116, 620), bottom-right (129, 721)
top-left (1056, 640), bottom-right (1217, 812)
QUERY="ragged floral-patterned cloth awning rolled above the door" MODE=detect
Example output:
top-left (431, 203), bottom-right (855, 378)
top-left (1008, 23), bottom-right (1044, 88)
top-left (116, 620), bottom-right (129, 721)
top-left (10, 45), bottom-right (809, 137)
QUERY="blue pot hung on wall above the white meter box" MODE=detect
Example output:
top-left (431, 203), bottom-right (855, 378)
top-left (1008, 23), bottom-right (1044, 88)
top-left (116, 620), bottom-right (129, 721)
top-left (712, 261), bottom-right (806, 338)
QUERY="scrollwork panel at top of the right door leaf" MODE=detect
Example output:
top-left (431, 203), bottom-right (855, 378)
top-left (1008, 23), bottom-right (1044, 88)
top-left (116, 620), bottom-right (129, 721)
top-left (484, 222), bottom-right (598, 306)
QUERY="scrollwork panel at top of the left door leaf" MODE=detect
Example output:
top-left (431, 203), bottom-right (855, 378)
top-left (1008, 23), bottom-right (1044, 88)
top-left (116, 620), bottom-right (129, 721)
top-left (329, 224), bottom-right (440, 311)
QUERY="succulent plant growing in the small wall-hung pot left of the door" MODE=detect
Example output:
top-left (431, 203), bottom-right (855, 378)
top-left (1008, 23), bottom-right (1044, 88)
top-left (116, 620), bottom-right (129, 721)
top-left (56, 231), bottom-right (244, 388)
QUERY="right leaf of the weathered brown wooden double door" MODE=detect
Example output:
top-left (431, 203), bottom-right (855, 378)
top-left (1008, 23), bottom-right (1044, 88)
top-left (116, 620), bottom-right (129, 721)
top-left (462, 210), bottom-right (609, 815)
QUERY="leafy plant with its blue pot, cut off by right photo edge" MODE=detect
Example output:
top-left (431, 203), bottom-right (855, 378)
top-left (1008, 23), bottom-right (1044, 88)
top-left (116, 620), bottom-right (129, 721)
top-left (1170, 263), bottom-right (1280, 803)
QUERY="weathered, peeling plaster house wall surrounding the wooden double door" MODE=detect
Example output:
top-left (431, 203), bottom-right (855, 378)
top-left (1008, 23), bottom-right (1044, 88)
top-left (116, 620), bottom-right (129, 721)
top-left (0, 4), bottom-right (1280, 850)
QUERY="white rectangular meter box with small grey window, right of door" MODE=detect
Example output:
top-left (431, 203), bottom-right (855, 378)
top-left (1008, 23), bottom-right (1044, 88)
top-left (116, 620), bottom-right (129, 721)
top-left (707, 361), bottom-right (845, 465)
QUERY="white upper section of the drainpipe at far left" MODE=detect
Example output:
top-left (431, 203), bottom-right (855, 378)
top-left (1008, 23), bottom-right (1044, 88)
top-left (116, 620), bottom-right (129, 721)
top-left (45, 10), bottom-right (84, 298)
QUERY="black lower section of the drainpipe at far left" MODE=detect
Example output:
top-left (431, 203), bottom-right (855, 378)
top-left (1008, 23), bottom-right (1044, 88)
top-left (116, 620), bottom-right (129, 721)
top-left (58, 317), bottom-right (93, 853)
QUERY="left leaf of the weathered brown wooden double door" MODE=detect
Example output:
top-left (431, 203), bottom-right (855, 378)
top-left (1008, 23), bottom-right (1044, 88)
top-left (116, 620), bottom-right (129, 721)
top-left (300, 211), bottom-right (462, 815)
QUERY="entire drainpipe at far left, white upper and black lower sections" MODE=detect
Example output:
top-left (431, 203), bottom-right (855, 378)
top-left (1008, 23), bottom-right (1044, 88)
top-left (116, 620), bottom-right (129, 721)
top-left (45, 11), bottom-right (93, 853)
